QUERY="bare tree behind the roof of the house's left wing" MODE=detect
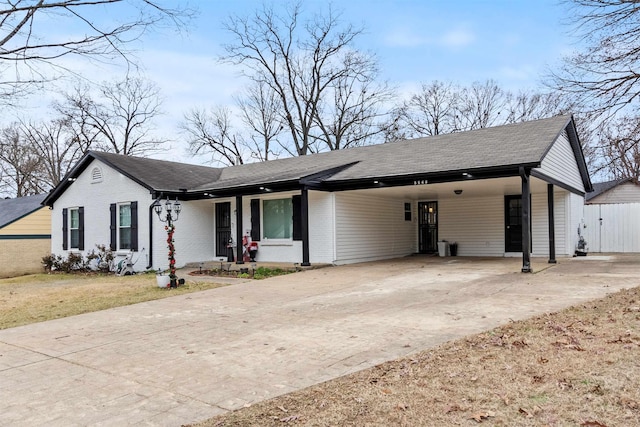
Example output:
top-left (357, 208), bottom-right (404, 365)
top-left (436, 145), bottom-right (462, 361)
top-left (56, 78), bottom-right (165, 156)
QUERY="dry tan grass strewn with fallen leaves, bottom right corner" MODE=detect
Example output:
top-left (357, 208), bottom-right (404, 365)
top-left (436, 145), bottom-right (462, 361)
top-left (195, 288), bottom-right (640, 427)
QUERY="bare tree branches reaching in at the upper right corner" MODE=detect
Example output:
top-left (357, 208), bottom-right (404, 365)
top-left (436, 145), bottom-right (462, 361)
top-left (545, 0), bottom-right (640, 179)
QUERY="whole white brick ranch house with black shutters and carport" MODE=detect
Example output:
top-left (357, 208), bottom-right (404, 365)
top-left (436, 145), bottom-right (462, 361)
top-left (43, 115), bottom-right (591, 272)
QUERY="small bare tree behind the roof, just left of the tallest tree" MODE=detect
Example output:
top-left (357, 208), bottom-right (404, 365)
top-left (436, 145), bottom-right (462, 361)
top-left (181, 108), bottom-right (244, 166)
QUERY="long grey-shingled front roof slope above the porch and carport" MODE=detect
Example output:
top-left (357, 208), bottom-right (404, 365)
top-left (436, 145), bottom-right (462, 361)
top-left (198, 116), bottom-right (570, 190)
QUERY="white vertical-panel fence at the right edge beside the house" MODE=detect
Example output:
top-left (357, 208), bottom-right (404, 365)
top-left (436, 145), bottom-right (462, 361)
top-left (583, 203), bottom-right (640, 252)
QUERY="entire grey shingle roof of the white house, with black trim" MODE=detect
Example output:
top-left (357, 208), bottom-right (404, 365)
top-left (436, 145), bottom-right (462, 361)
top-left (45, 115), bottom-right (591, 204)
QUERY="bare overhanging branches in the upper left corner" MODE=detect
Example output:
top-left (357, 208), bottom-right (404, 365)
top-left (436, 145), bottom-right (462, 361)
top-left (0, 0), bottom-right (193, 101)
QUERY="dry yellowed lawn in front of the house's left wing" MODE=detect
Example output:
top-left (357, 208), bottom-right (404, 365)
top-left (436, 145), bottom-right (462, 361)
top-left (0, 274), bottom-right (225, 329)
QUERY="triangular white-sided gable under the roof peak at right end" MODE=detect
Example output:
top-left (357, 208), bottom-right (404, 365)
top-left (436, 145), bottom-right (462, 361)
top-left (540, 132), bottom-right (584, 192)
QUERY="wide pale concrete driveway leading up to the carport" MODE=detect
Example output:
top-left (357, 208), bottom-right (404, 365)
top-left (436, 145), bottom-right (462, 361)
top-left (0, 255), bottom-right (640, 426)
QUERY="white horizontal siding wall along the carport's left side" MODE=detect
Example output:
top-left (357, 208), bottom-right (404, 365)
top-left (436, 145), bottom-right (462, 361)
top-left (335, 192), bottom-right (417, 264)
